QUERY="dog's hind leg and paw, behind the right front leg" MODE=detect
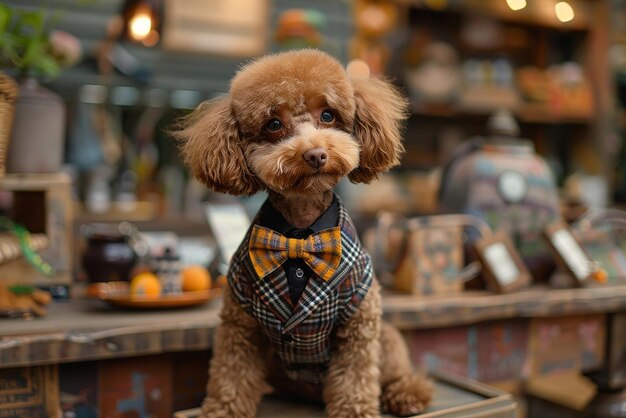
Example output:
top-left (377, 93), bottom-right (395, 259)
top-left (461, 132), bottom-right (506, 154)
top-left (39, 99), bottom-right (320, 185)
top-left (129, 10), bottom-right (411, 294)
top-left (380, 322), bottom-right (433, 416)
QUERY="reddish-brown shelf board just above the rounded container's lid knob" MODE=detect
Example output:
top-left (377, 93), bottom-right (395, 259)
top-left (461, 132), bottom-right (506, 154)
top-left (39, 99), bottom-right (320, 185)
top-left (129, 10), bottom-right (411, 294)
top-left (411, 105), bottom-right (593, 125)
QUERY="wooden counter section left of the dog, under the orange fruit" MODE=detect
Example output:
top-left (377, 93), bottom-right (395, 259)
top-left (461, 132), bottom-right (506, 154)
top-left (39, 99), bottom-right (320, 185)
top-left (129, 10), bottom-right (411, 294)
top-left (0, 300), bottom-right (220, 368)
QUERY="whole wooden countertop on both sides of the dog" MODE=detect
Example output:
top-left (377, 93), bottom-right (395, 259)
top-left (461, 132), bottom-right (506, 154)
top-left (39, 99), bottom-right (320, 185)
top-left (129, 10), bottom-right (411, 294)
top-left (0, 286), bottom-right (626, 368)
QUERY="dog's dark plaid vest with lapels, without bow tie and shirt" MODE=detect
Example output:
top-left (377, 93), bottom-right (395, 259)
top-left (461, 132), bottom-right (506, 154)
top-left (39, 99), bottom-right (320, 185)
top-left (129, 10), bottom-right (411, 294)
top-left (228, 198), bottom-right (374, 383)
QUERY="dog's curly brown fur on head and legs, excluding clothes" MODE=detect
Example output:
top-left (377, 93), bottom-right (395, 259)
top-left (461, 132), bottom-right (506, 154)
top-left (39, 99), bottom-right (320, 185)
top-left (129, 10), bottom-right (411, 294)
top-left (176, 50), bottom-right (432, 418)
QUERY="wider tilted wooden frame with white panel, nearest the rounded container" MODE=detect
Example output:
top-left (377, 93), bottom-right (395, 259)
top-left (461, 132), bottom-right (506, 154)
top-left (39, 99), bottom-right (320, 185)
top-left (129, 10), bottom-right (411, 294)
top-left (473, 232), bottom-right (531, 293)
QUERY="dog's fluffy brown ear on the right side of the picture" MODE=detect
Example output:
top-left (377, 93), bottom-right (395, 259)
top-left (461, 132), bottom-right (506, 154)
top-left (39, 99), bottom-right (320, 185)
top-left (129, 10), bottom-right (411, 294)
top-left (348, 77), bottom-right (408, 183)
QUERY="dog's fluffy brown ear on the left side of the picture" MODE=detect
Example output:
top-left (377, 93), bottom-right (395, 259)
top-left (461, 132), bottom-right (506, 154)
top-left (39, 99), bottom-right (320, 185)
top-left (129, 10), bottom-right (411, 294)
top-left (174, 96), bottom-right (260, 195)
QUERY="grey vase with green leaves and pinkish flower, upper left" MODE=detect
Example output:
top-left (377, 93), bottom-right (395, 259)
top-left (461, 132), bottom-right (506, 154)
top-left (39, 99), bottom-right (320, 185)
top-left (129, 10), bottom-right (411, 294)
top-left (0, 4), bottom-right (81, 173)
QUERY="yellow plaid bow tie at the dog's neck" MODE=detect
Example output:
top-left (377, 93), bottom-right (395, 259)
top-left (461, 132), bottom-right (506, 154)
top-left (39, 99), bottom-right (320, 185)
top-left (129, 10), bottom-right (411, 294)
top-left (248, 225), bottom-right (341, 280)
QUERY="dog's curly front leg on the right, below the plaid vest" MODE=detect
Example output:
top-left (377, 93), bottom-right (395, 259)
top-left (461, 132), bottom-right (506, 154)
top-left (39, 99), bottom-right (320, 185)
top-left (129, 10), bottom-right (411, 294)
top-left (324, 282), bottom-right (382, 418)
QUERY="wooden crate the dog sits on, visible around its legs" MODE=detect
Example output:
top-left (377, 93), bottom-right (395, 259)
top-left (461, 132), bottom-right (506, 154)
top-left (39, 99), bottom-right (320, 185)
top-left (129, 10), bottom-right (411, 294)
top-left (174, 373), bottom-right (517, 418)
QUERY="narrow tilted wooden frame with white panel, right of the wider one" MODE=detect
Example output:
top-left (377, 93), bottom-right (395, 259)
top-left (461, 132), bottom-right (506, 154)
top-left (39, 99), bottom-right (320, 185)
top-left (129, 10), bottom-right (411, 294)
top-left (543, 220), bottom-right (594, 287)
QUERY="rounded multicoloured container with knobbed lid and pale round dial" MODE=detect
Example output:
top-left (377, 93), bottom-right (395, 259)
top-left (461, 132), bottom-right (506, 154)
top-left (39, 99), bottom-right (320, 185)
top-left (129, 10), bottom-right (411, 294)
top-left (439, 111), bottom-right (560, 281)
